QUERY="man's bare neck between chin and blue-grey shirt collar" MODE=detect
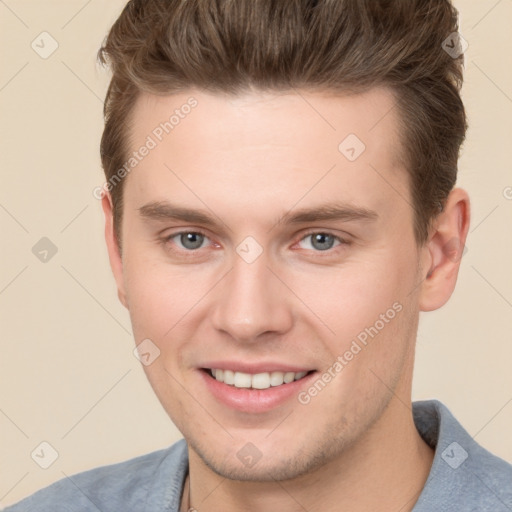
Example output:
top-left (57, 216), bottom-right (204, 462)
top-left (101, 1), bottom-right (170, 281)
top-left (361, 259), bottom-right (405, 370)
top-left (181, 398), bottom-right (434, 512)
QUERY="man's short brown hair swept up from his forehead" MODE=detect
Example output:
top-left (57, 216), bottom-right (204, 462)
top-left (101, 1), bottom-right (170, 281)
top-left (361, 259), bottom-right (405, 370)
top-left (98, 0), bottom-right (467, 248)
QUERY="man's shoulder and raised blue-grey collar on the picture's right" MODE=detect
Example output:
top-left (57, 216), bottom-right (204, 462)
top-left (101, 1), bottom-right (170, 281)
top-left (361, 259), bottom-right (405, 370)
top-left (413, 400), bottom-right (512, 512)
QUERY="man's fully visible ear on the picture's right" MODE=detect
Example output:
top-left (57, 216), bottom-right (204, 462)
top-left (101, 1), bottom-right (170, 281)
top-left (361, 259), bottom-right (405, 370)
top-left (419, 188), bottom-right (470, 311)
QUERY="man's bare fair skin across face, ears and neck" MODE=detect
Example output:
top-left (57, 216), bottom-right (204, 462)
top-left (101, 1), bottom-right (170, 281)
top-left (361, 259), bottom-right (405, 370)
top-left (102, 88), bottom-right (469, 512)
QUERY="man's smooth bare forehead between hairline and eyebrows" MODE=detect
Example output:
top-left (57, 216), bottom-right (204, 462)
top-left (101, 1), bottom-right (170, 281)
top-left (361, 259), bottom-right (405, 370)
top-left (125, 88), bottom-right (408, 226)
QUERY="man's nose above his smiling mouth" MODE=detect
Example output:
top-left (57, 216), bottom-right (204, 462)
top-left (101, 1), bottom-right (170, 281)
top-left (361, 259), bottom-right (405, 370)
top-left (211, 252), bottom-right (293, 343)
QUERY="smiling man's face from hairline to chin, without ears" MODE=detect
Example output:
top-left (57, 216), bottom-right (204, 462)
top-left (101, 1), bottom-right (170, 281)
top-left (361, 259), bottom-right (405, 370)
top-left (109, 89), bottom-right (428, 480)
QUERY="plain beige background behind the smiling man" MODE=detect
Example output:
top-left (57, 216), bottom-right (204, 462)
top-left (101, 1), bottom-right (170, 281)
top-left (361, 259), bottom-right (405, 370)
top-left (0, 0), bottom-right (512, 505)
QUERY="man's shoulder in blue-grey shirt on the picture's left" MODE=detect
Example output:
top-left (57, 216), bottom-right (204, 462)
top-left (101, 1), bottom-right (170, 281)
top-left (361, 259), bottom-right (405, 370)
top-left (4, 439), bottom-right (188, 512)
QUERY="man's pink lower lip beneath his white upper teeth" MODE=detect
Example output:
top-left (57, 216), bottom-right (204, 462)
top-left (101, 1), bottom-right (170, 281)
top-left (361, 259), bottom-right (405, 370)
top-left (199, 370), bottom-right (317, 413)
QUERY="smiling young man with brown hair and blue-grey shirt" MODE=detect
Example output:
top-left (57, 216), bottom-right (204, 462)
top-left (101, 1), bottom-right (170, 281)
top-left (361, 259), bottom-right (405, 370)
top-left (8, 0), bottom-right (512, 512)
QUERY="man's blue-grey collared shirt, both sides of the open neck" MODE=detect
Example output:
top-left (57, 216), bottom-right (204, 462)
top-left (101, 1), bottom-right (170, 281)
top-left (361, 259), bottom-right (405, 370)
top-left (4, 400), bottom-right (512, 512)
